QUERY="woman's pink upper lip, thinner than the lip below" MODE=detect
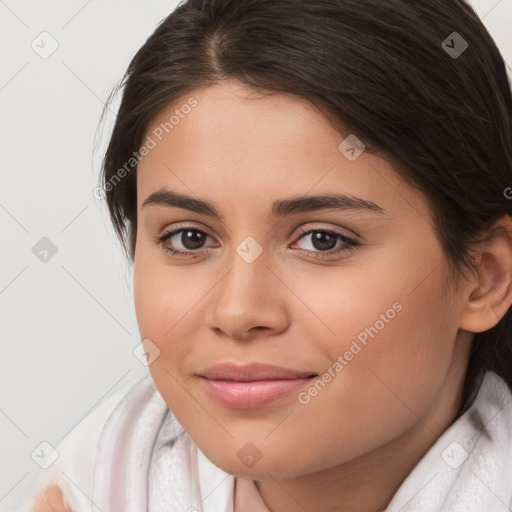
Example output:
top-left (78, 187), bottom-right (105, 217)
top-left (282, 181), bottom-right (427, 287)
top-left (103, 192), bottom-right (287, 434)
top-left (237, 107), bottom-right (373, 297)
top-left (199, 362), bottom-right (316, 382)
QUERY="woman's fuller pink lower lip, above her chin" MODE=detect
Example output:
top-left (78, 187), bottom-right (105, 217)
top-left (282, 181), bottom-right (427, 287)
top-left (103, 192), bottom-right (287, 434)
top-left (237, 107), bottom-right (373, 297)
top-left (197, 376), bottom-right (316, 409)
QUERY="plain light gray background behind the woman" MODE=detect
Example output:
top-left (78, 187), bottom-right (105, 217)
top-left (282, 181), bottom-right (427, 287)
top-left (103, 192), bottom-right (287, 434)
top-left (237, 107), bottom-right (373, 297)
top-left (0, 0), bottom-right (512, 510)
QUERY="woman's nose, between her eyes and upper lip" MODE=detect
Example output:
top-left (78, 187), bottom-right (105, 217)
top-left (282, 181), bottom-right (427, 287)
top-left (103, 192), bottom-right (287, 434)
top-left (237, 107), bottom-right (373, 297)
top-left (206, 243), bottom-right (290, 341)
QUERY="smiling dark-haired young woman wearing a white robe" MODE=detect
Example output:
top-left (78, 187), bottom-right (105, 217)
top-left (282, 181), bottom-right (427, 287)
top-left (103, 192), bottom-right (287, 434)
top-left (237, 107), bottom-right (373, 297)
top-left (20, 0), bottom-right (512, 512)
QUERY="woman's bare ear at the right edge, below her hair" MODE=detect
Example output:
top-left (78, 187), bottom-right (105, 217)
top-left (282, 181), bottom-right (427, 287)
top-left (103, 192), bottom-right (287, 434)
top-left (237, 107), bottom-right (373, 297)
top-left (460, 214), bottom-right (512, 332)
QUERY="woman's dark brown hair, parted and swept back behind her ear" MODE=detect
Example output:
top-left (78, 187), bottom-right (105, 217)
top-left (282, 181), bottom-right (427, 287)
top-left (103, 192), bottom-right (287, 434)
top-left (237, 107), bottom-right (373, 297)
top-left (100, 0), bottom-right (512, 414)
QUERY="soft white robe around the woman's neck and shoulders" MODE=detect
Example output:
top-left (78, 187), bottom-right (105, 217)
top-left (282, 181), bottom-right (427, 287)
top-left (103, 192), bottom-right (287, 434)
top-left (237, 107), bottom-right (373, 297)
top-left (14, 372), bottom-right (512, 512)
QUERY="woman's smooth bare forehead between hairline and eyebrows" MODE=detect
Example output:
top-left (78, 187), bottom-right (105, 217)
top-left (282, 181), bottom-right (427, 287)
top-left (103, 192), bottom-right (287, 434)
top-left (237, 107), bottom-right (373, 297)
top-left (137, 82), bottom-right (429, 223)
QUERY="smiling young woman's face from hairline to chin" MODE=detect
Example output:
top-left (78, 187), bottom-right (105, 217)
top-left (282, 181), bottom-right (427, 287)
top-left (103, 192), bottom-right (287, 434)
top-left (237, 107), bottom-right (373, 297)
top-left (134, 82), bottom-right (469, 478)
